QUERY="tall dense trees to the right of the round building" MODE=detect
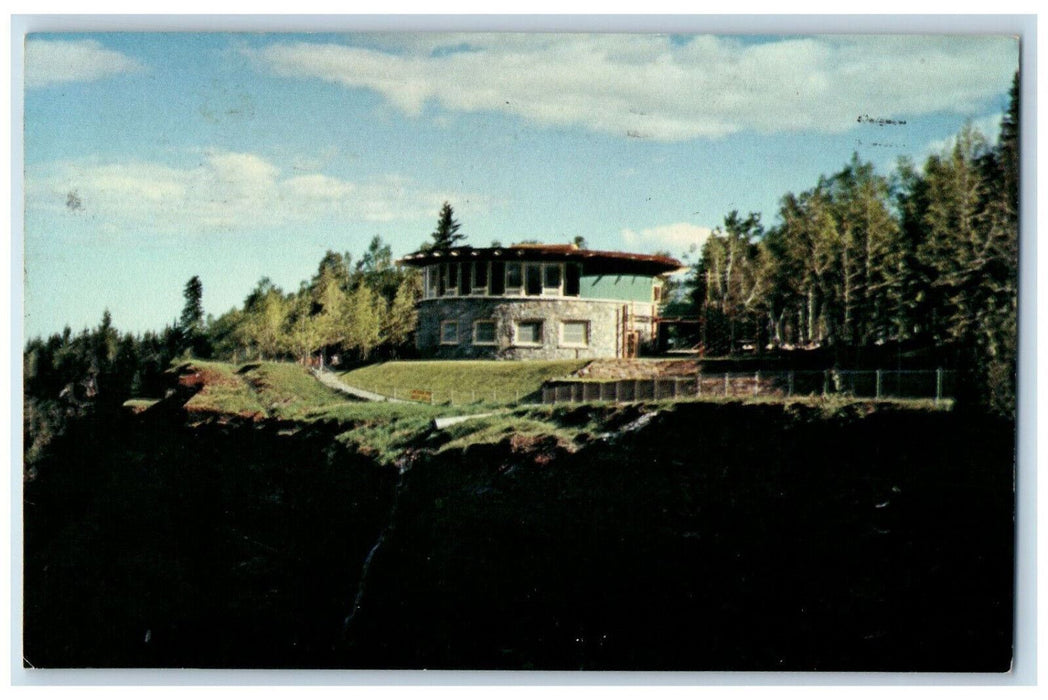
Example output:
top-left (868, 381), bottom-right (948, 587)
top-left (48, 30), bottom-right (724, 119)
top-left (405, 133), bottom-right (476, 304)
top-left (693, 74), bottom-right (1020, 414)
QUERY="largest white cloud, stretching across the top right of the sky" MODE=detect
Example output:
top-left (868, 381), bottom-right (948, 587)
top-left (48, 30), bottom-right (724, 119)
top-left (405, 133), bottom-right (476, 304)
top-left (244, 34), bottom-right (1018, 140)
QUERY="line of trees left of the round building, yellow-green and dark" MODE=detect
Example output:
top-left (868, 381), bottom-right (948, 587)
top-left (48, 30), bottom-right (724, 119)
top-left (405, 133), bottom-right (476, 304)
top-left (23, 237), bottom-right (421, 475)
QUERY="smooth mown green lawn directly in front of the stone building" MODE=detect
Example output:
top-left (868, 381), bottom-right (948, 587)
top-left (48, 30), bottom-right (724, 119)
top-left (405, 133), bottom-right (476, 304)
top-left (340, 359), bottom-right (589, 404)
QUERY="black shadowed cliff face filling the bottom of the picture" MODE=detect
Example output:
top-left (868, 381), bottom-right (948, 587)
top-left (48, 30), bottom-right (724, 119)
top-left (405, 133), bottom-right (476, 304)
top-left (25, 404), bottom-right (1013, 671)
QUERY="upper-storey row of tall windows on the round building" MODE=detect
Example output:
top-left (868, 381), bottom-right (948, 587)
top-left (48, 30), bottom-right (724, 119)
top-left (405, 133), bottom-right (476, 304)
top-left (424, 260), bottom-right (582, 299)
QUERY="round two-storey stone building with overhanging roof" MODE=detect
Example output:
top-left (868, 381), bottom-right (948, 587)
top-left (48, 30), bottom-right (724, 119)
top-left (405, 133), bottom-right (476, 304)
top-left (400, 245), bottom-right (680, 359)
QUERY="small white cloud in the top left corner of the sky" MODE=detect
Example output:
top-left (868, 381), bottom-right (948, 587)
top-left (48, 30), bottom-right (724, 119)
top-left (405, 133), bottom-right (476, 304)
top-left (25, 39), bottom-right (144, 88)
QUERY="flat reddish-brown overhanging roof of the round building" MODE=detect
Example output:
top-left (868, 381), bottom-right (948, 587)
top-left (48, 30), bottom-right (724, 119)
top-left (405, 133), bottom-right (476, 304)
top-left (397, 243), bottom-right (683, 276)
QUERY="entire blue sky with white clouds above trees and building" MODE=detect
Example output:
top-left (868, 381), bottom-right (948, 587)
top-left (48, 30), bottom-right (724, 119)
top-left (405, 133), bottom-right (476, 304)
top-left (23, 31), bottom-right (1019, 337)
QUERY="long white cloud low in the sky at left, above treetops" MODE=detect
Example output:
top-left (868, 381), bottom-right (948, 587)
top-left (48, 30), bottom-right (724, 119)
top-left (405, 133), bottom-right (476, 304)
top-left (26, 151), bottom-right (483, 234)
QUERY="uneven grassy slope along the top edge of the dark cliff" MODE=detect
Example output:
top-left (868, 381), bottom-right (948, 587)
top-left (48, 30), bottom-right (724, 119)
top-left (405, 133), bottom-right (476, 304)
top-left (167, 360), bottom-right (948, 464)
